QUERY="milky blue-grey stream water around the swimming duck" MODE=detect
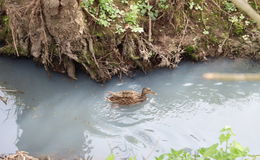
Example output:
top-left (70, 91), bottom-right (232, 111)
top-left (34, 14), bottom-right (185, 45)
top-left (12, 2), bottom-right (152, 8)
top-left (0, 58), bottom-right (260, 159)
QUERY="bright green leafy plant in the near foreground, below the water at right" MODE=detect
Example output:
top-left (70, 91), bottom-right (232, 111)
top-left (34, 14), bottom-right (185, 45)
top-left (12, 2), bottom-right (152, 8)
top-left (106, 126), bottom-right (256, 160)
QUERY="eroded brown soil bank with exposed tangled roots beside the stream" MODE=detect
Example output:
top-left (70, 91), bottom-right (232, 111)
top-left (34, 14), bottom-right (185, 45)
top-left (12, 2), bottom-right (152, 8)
top-left (0, 0), bottom-right (260, 82)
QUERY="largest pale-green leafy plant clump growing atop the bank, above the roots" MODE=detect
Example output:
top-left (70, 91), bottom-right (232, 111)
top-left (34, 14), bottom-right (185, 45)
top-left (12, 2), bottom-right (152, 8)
top-left (81, 0), bottom-right (169, 34)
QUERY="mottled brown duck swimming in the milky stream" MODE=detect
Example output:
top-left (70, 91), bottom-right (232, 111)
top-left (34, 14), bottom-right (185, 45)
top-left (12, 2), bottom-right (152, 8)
top-left (106, 88), bottom-right (157, 105)
